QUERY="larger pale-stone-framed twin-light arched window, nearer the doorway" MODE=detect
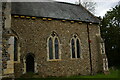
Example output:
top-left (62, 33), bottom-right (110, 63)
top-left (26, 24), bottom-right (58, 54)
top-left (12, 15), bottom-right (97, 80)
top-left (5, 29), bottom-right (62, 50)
top-left (47, 31), bottom-right (61, 60)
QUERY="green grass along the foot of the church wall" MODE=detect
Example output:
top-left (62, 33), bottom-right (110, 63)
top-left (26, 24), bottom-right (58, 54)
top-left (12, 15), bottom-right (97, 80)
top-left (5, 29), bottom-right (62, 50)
top-left (16, 69), bottom-right (120, 80)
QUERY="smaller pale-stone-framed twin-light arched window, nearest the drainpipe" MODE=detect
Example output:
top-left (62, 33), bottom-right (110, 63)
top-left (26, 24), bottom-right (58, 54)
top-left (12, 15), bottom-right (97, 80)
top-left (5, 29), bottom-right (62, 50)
top-left (70, 34), bottom-right (82, 58)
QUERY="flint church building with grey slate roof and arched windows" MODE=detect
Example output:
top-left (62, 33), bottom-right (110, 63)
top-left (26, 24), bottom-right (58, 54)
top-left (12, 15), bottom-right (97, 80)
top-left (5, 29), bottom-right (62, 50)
top-left (0, 2), bottom-right (108, 78)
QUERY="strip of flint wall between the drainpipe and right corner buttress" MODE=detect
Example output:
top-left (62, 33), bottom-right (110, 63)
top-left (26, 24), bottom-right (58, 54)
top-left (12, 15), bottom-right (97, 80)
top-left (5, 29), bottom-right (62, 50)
top-left (89, 25), bottom-right (102, 74)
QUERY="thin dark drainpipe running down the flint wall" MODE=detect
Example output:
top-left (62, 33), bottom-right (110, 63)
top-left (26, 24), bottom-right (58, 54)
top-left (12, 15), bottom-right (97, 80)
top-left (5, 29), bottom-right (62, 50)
top-left (87, 23), bottom-right (92, 75)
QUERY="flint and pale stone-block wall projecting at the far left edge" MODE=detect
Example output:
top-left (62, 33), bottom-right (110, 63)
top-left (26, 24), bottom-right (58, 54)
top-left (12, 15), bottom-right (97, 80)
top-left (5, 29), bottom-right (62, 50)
top-left (0, 2), bottom-right (14, 77)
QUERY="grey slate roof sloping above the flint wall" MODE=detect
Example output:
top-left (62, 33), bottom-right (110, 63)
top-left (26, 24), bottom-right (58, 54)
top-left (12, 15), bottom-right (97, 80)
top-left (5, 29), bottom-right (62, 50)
top-left (12, 2), bottom-right (99, 23)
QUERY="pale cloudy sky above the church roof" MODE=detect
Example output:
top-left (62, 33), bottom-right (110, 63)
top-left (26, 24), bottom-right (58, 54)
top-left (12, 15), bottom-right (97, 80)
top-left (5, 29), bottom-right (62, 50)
top-left (56, 0), bottom-right (120, 17)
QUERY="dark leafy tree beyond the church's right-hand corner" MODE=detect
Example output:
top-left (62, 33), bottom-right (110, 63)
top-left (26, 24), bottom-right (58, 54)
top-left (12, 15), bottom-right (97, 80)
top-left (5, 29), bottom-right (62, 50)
top-left (100, 4), bottom-right (120, 67)
